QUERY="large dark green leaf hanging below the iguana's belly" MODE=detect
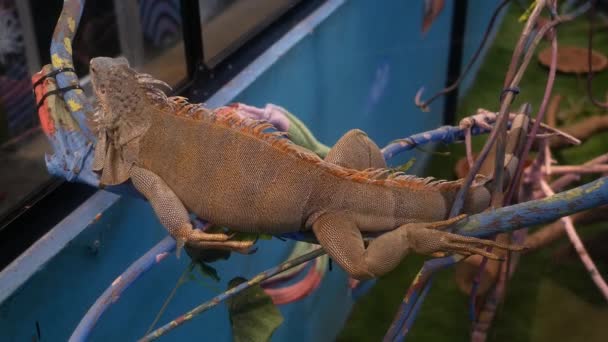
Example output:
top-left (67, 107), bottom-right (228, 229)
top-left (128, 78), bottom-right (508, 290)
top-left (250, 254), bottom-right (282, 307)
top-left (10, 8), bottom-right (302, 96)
top-left (227, 277), bottom-right (283, 342)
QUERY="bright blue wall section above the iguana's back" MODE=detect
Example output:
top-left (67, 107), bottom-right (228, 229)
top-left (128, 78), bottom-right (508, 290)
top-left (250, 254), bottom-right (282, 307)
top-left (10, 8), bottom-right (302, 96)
top-left (238, 0), bottom-right (452, 151)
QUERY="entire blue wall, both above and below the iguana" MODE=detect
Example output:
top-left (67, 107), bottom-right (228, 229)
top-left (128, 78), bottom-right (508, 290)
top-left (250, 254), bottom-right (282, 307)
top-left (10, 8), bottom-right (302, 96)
top-left (0, 0), bottom-right (504, 341)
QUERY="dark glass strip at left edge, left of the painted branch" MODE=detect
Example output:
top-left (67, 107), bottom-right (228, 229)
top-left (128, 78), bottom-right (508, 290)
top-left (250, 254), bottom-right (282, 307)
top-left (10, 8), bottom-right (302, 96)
top-left (0, 0), bottom-right (49, 216)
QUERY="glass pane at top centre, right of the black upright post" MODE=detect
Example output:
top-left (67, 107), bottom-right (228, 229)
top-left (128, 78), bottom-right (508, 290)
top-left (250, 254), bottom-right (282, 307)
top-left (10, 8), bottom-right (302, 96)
top-left (199, 0), bottom-right (300, 67)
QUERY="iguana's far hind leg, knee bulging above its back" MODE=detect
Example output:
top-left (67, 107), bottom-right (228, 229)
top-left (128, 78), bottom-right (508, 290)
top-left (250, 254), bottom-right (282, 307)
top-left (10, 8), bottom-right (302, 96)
top-left (325, 129), bottom-right (386, 170)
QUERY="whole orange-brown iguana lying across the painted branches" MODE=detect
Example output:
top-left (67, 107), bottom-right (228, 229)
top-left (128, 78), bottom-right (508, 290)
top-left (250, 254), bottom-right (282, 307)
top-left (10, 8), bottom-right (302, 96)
top-left (90, 57), bottom-right (527, 279)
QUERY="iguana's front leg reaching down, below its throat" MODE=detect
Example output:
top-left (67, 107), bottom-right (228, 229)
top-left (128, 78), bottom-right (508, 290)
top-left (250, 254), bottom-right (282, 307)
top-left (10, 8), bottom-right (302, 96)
top-left (130, 166), bottom-right (253, 255)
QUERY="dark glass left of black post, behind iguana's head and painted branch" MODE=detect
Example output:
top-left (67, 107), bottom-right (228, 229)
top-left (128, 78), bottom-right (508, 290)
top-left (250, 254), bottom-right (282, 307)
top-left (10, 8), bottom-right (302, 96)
top-left (0, 0), bottom-right (187, 220)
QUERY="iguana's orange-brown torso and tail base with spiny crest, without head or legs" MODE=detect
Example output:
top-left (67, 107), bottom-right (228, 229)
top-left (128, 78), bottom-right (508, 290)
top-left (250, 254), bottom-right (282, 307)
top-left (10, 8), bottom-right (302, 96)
top-left (137, 98), bottom-right (484, 233)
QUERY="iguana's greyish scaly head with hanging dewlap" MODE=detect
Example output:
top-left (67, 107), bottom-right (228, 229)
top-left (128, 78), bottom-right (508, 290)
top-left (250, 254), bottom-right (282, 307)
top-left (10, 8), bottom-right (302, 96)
top-left (90, 57), bottom-right (170, 184)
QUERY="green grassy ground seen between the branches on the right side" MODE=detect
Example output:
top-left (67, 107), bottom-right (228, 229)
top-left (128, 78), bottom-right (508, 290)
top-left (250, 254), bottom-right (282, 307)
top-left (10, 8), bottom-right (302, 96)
top-left (338, 6), bottom-right (608, 342)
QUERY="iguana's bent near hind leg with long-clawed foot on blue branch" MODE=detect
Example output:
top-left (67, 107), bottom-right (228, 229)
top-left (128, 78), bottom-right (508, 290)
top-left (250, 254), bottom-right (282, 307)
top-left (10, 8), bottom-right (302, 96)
top-left (312, 212), bottom-right (522, 280)
